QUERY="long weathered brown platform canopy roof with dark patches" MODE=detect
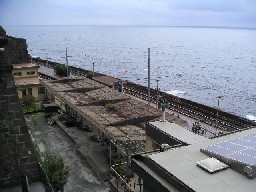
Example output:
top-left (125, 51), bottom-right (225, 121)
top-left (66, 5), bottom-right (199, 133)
top-left (44, 78), bottom-right (161, 141)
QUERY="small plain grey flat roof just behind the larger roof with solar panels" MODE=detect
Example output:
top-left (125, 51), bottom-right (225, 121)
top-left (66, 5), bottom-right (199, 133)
top-left (149, 121), bottom-right (209, 144)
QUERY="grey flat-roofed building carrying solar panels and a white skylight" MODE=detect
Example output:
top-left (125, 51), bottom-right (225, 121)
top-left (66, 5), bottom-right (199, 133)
top-left (131, 121), bottom-right (256, 192)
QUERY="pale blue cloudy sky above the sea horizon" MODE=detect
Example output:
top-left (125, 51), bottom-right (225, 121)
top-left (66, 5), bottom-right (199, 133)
top-left (0, 0), bottom-right (256, 28)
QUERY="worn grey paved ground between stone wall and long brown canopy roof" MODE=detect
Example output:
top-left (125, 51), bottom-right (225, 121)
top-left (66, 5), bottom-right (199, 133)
top-left (27, 114), bottom-right (109, 192)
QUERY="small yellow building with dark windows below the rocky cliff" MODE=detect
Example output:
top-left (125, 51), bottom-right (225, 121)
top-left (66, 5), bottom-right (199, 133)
top-left (12, 63), bottom-right (45, 100)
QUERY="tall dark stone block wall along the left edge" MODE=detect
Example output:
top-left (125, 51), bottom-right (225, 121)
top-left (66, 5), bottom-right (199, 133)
top-left (0, 38), bottom-right (39, 188)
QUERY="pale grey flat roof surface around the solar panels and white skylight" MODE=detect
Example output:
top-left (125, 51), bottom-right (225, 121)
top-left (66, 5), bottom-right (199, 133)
top-left (148, 129), bottom-right (256, 192)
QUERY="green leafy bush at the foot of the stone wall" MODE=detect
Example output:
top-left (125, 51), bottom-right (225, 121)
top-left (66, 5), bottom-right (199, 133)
top-left (41, 153), bottom-right (69, 191)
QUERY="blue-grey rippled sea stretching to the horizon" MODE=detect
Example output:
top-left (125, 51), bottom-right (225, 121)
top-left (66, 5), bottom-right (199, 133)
top-left (4, 26), bottom-right (256, 118)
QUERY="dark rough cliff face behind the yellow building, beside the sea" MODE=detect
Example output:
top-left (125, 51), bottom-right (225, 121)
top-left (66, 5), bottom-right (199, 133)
top-left (0, 26), bottom-right (30, 64)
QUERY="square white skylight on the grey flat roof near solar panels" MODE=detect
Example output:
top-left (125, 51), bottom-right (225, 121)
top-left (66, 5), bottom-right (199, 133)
top-left (197, 158), bottom-right (228, 173)
